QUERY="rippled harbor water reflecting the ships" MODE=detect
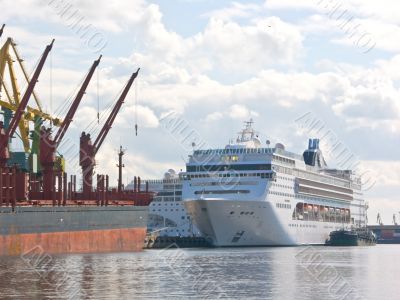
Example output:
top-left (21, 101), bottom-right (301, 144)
top-left (0, 245), bottom-right (400, 300)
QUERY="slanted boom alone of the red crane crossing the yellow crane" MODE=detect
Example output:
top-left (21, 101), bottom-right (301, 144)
top-left (1, 39), bottom-right (54, 147)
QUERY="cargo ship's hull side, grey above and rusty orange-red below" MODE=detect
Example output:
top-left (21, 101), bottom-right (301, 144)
top-left (0, 206), bottom-right (148, 256)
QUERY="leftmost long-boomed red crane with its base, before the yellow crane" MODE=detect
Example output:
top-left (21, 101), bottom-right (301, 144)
top-left (0, 38), bottom-right (54, 168)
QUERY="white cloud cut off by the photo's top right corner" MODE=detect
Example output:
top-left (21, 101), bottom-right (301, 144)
top-left (265, 0), bottom-right (400, 53)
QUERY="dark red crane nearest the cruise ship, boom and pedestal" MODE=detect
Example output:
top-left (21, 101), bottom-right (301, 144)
top-left (79, 68), bottom-right (140, 199)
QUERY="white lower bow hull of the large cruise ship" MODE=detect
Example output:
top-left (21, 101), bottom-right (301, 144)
top-left (184, 199), bottom-right (343, 247)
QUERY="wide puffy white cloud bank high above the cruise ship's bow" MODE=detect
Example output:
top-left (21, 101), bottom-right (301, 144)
top-left (105, 14), bottom-right (303, 77)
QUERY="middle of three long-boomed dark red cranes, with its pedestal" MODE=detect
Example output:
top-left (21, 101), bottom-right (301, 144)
top-left (39, 55), bottom-right (101, 200)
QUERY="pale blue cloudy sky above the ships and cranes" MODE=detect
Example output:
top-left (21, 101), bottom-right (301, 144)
top-left (0, 0), bottom-right (400, 223)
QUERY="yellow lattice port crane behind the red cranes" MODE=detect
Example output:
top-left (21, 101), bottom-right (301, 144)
top-left (0, 34), bottom-right (62, 153)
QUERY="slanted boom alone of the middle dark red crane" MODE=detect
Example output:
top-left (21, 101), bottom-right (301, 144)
top-left (53, 55), bottom-right (102, 147)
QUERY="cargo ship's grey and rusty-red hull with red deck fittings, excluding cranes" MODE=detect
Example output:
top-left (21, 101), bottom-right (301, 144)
top-left (0, 167), bottom-right (153, 256)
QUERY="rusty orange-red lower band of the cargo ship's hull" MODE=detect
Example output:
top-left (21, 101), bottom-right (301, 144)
top-left (0, 228), bottom-right (146, 256)
